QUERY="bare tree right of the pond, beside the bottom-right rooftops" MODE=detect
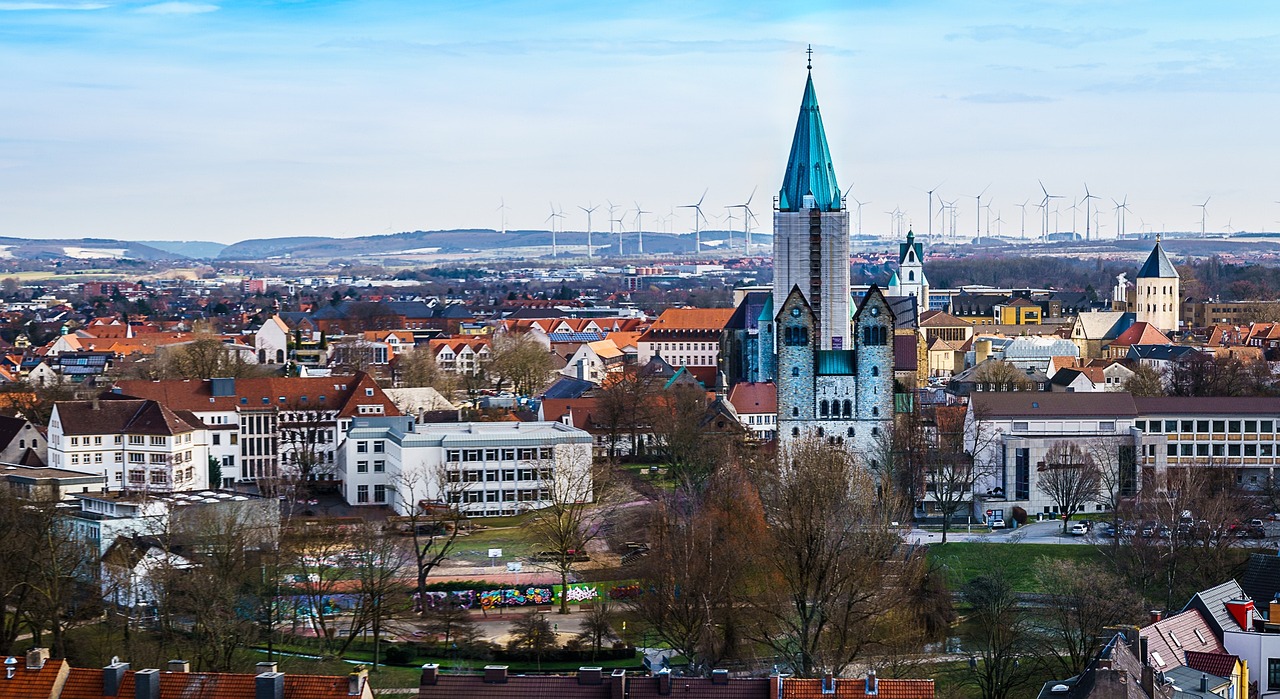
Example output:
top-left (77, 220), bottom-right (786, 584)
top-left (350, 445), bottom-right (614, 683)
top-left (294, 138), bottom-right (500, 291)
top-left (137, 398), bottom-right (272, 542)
top-left (1036, 561), bottom-right (1143, 675)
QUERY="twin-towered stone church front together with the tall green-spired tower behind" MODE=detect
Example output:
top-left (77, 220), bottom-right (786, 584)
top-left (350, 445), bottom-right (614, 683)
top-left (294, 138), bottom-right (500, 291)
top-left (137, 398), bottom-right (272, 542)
top-left (759, 64), bottom-right (901, 455)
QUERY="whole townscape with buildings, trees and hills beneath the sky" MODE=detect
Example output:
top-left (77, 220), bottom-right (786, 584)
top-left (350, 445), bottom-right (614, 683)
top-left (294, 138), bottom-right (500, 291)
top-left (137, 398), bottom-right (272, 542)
top-left (0, 65), bottom-right (1280, 699)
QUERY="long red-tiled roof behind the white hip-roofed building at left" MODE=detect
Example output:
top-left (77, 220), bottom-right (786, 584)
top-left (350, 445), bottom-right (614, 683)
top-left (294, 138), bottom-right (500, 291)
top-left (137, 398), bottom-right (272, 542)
top-left (115, 373), bottom-right (401, 417)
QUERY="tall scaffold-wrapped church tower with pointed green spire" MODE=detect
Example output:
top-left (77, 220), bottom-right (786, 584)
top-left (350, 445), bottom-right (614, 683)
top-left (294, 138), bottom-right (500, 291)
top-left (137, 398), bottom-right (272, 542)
top-left (773, 67), bottom-right (852, 350)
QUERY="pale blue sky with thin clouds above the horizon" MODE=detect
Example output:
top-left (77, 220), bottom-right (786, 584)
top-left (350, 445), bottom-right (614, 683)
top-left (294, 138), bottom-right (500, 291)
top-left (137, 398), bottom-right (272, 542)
top-left (0, 0), bottom-right (1280, 242)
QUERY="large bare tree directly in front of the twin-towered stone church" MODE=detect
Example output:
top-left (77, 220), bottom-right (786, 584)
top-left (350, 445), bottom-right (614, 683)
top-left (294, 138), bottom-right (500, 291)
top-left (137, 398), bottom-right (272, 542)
top-left (751, 439), bottom-right (906, 677)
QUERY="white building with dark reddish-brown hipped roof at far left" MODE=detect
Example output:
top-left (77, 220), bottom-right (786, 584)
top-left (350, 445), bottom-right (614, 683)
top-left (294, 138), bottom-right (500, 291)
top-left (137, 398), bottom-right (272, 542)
top-left (49, 399), bottom-right (209, 493)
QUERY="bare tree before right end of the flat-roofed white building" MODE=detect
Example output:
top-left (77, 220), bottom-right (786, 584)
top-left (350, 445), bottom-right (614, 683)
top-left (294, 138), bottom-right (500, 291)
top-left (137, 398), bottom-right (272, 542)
top-left (526, 444), bottom-right (614, 615)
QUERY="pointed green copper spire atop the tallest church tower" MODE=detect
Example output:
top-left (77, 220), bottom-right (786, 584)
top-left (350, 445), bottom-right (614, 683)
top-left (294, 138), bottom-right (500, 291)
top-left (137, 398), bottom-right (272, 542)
top-left (778, 73), bottom-right (841, 211)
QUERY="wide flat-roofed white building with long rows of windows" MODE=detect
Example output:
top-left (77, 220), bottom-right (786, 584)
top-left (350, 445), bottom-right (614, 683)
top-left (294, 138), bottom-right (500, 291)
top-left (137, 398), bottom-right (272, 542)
top-left (338, 417), bottom-right (593, 516)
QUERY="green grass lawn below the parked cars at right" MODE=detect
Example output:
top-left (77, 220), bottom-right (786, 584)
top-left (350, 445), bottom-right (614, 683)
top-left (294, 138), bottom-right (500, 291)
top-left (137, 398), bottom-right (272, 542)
top-left (929, 542), bottom-right (1102, 593)
